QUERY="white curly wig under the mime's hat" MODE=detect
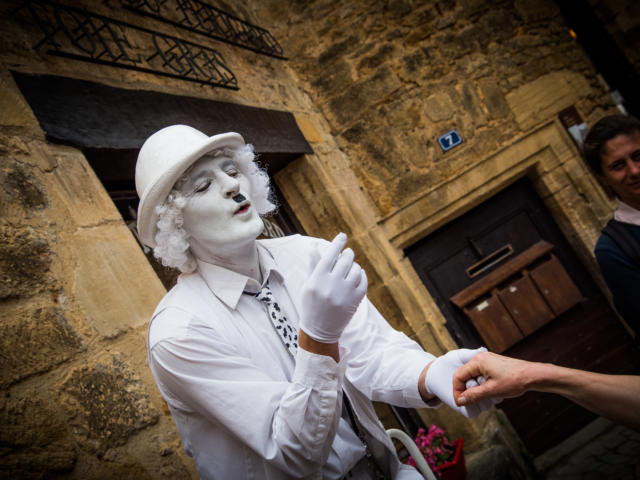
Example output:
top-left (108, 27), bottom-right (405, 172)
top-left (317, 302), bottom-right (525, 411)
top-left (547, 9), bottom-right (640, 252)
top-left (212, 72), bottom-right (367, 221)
top-left (153, 144), bottom-right (276, 273)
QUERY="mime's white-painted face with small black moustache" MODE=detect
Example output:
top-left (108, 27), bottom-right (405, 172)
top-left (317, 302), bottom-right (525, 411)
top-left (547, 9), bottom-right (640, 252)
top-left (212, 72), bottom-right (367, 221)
top-left (181, 156), bottom-right (264, 261)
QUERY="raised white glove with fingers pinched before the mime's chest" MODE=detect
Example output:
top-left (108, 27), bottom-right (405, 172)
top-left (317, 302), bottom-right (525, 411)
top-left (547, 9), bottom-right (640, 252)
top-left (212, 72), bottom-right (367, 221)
top-left (300, 233), bottom-right (367, 343)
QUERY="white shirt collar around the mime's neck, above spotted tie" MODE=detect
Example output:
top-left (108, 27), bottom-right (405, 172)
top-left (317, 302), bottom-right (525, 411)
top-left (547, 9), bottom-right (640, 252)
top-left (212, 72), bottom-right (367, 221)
top-left (196, 241), bottom-right (283, 310)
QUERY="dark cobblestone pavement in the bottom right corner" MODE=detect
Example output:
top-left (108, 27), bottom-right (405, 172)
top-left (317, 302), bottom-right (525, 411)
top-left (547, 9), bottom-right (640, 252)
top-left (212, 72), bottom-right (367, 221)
top-left (535, 418), bottom-right (640, 480)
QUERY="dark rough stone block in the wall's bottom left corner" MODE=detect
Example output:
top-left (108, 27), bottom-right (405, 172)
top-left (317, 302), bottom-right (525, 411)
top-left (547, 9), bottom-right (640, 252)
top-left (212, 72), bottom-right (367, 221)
top-left (0, 389), bottom-right (77, 479)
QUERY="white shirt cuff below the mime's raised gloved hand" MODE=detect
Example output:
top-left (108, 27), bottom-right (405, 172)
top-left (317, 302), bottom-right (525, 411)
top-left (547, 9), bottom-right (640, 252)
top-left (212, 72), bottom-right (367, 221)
top-left (292, 348), bottom-right (344, 390)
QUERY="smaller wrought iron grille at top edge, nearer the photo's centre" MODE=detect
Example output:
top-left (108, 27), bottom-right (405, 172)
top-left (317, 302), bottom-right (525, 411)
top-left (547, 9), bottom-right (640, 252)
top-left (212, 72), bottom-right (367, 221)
top-left (122, 0), bottom-right (286, 60)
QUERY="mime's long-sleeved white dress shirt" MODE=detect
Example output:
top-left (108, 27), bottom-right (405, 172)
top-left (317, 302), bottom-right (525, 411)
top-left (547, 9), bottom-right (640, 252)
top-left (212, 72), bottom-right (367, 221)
top-left (148, 235), bottom-right (434, 480)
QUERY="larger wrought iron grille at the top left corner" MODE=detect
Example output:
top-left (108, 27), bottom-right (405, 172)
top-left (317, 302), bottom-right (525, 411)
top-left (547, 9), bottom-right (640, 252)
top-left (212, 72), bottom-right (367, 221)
top-left (13, 0), bottom-right (238, 90)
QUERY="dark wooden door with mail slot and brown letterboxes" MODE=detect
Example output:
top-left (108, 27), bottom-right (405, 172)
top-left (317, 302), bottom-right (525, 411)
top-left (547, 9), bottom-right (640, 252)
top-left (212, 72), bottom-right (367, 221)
top-left (406, 179), bottom-right (640, 454)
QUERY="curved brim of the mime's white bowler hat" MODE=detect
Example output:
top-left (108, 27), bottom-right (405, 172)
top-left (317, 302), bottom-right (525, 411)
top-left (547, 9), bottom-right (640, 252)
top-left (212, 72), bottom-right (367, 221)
top-left (137, 132), bottom-right (245, 248)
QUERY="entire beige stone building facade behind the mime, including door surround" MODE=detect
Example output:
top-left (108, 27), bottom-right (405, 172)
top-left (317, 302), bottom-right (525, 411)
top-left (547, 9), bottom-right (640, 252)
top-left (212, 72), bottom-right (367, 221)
top-left (0, 0), bottom-right (638, 479)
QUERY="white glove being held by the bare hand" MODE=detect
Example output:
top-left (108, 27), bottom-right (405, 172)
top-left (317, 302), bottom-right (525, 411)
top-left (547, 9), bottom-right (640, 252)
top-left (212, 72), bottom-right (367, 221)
top-left (424, 347), bottom-right (494, 418)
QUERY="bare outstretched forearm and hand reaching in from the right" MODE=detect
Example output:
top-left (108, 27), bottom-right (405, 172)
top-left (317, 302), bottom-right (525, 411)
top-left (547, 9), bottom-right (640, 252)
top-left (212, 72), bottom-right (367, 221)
top-left (453, 352), bottom-right (640, 430)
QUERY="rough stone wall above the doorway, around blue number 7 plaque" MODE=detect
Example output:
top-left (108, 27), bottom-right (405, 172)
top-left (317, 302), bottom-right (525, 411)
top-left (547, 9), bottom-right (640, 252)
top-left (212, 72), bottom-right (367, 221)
top-left (255, 0), bottom-right (610, 220)
